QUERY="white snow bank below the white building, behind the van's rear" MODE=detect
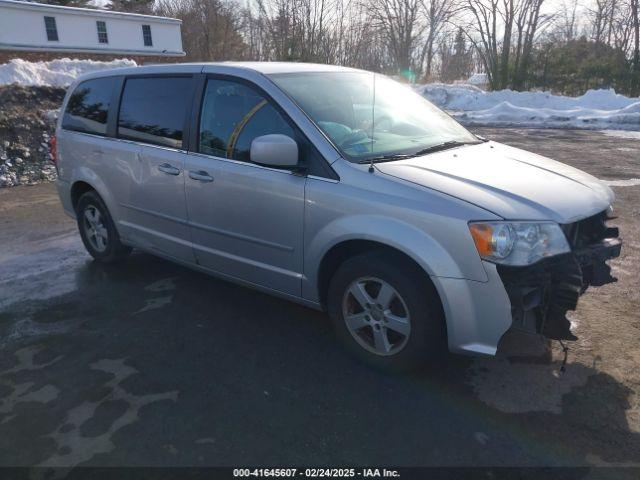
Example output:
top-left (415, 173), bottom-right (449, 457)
top-left (0, 58), bottom-right (136, 87)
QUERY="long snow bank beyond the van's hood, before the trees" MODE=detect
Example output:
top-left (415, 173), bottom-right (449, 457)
top-left (415, 83), bottom-right (640, 130)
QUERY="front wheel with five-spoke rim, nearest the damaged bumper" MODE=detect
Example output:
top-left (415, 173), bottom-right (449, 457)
top-left (327, 250), bottom-right (447, 372)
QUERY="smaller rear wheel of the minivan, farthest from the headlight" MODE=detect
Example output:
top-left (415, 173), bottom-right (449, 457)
top-left (76, 191), bottom-right (131, 263)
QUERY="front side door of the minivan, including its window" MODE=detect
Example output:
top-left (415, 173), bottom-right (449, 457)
top-left (185, 78), bottom-right (306, 296)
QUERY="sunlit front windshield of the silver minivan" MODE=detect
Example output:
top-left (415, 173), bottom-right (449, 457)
top-left (270, 72), bottom-right (479, 162)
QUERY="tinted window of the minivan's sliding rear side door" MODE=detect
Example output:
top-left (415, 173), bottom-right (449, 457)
top-left (118, 77), bottom-right (191, 148)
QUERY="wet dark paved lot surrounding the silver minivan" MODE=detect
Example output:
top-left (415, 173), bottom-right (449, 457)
top-left (0, 129), bottom-right (640, 468)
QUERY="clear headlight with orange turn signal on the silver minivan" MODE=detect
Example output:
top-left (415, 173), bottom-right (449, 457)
top-left (469, 222), bottom-right (571, 266)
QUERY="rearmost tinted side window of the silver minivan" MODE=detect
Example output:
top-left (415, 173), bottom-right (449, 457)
top-left (62, 77), bottom-right (118, 135)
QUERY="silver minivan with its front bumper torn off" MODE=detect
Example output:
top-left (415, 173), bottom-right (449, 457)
top-left (56, 63), bottom-right (621, 369)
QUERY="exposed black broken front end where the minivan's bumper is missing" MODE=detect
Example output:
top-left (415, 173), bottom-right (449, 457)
top-left (497, 211), bottom-right (622, 340)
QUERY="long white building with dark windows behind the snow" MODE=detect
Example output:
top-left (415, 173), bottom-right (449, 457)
top-left (0, 0), bottom-right (185, 57)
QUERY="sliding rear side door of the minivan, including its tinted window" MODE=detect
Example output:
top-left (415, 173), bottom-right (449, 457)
top-left (117, 76), bottom-right (194, 261)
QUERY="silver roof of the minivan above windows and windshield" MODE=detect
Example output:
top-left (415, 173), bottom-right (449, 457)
top-left (79, 62), bottom-right (360, 79)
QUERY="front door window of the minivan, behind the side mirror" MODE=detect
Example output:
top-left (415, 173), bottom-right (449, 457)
top-left (199, 79), bottom-right (295, 162)
